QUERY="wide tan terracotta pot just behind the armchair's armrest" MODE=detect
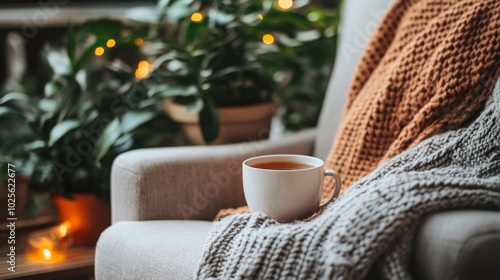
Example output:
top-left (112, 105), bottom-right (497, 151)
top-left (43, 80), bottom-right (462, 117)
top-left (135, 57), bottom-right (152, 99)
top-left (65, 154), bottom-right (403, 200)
top-left (164, 99), bottom-right (276, 145)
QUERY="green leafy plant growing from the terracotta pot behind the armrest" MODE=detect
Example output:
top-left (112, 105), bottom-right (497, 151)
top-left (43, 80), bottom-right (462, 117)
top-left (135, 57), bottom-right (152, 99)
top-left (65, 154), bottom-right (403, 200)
top-left (131, 0), bottom-right (338, 142)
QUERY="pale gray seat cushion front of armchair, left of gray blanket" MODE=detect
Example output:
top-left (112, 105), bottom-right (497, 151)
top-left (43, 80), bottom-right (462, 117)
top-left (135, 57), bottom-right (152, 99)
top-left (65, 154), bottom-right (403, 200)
top-left (95, 221), bottom-right (212, 280)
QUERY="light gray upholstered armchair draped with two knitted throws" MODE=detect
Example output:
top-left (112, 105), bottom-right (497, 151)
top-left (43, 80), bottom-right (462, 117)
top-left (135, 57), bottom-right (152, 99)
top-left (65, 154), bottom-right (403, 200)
top-left (95, 0), bottom-right (500, 280)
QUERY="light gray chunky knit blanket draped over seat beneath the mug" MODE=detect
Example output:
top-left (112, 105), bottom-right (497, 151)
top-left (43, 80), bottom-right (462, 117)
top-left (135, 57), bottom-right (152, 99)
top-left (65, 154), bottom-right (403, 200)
top-left (195, 77), bottom-right (500, 279)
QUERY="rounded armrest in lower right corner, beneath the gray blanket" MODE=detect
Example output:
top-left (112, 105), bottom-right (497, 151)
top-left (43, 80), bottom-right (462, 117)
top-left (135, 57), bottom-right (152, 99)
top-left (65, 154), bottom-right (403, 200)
top-left (413, 210), bottom-right (500, 280)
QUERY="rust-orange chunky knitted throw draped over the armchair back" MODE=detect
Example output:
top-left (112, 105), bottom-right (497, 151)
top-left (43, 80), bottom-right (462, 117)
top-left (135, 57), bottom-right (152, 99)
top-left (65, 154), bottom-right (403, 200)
top-left (325, 0), bottom-right (500, 196)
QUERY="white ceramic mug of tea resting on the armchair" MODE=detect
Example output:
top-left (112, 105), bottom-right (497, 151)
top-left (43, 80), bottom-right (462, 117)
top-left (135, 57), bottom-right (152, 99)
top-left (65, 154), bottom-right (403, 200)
top-left (243, 155), bottom-right (341, 222)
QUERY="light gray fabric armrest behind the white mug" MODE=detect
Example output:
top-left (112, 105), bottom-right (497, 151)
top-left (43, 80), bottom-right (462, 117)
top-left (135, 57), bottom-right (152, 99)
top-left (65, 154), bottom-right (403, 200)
top-left (111, 129), bottom-right (315, 223)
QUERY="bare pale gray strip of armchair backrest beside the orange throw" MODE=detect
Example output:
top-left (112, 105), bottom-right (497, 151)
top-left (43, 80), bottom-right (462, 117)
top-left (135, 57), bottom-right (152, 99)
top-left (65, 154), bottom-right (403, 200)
top-left (314, 0), bottom-right (392, 159)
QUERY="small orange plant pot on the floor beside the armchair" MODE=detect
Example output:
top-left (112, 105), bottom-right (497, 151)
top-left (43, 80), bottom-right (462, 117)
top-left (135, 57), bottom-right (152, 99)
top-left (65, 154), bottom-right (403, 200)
top-left (54, 194), bottom-right (111, 246)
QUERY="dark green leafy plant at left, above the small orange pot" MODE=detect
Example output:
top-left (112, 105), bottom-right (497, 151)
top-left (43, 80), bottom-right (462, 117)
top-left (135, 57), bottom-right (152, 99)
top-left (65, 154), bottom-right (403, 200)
top-left (0, 20), bottom-right (176, 244)
